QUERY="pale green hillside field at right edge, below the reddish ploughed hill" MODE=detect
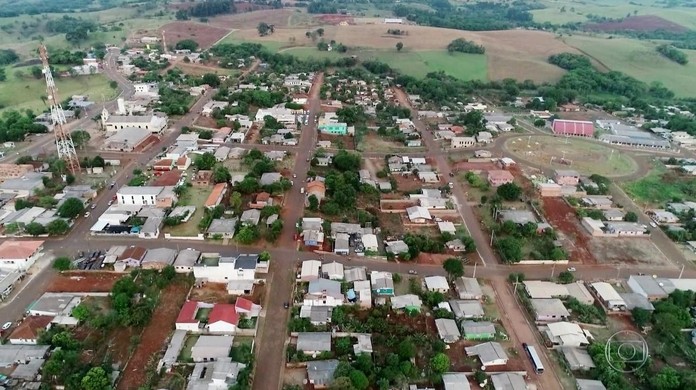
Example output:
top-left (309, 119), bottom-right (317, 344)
top-left (562, 35), bottom-right (696, 97)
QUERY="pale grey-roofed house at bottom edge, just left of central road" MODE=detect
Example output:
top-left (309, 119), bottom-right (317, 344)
top-left (187, 357), bottom-right (246, 390)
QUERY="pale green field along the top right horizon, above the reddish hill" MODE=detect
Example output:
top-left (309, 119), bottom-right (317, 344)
top-left (531, 0), bottom-right (696, 29)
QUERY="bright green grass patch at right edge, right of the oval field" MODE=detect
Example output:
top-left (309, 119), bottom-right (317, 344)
top-left (623, 163), bottom-right (696, 207)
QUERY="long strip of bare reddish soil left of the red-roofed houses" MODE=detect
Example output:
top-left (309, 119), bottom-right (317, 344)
top-left (117, 282), bottom-right (189, 390)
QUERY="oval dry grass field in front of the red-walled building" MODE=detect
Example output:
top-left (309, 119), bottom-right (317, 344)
top-left (505, 136), bottom-right (638, 176)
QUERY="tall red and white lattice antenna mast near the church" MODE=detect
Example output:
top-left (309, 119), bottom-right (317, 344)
top-left (39, 45), bottom-right (80, 175)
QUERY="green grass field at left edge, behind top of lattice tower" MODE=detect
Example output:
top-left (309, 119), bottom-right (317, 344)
top-left (0, 67), bottom-right (117, 113)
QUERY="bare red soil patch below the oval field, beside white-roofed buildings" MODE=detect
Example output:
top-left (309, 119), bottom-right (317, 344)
top-left (543, 198), bottom-right (597, 264)
